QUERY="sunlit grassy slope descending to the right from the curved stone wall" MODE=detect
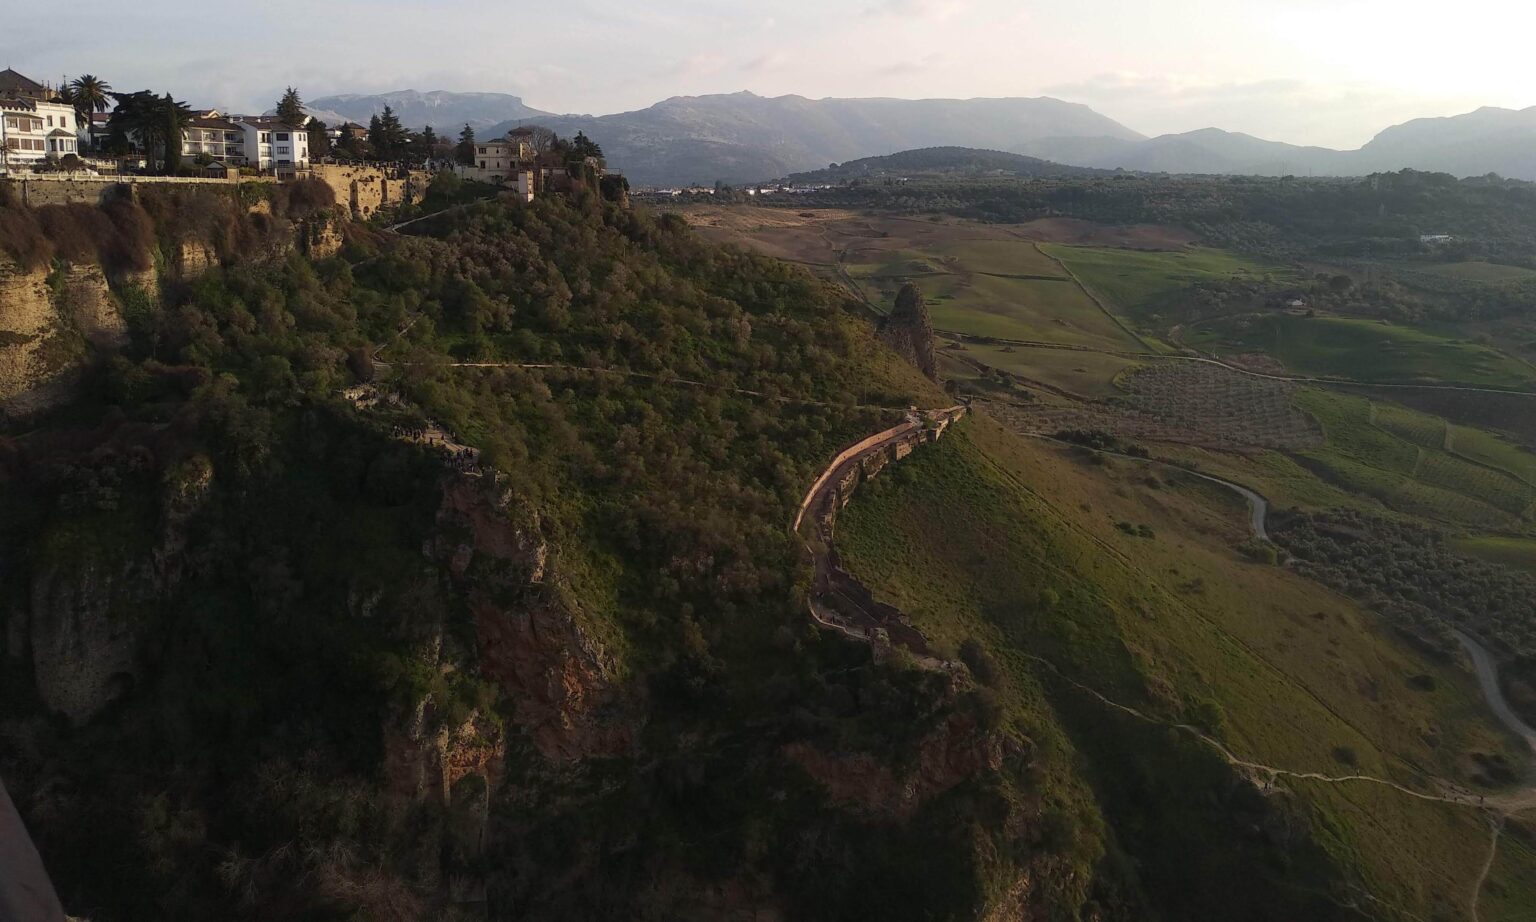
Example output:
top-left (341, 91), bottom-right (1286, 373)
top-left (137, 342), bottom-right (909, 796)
top-left (839, 420), bottom-right (1533, 919)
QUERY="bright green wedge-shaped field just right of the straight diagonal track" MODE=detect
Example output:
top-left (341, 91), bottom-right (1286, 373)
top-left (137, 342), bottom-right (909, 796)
top-left (1043, 244), bottom-right (1295, 321)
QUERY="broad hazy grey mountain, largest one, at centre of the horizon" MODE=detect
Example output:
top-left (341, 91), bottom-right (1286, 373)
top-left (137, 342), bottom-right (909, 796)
top-left (487, 92), bottom-right (1140, 186)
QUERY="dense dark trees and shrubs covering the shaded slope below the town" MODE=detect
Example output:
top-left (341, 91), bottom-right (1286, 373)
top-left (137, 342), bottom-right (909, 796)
top-left (0, 194), bottom-right (1124, 920)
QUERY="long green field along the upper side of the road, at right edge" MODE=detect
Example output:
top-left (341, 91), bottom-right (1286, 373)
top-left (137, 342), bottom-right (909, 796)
top-left (1184, 313), bottom-right (1536, 389)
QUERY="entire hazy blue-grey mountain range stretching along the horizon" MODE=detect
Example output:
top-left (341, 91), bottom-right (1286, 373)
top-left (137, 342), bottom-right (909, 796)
top-left (296, 91), bottom-right (1536, 186)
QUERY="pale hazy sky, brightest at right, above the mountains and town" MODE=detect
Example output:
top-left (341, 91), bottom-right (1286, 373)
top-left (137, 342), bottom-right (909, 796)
top-left (0, 0), bottom-right (1536, 146)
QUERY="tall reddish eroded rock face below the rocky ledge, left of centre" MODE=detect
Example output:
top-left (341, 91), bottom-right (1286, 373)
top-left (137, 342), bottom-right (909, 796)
top-left (429, 475), bottom-right (633, 761)
